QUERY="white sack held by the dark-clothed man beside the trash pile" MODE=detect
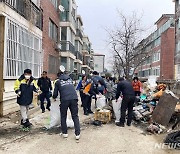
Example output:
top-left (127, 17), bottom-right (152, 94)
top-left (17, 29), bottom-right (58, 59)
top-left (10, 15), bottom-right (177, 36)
top-left (112, 97), bottom-right (122, 122)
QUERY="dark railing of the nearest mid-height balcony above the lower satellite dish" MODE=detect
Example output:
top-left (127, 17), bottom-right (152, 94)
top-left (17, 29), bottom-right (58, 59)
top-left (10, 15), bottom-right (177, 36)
top-left (60, 41), bottom-right (76, 55)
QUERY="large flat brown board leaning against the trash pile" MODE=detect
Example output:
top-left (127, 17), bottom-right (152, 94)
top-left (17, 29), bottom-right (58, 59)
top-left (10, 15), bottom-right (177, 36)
top-left (152, 93), bottom-right (178, 126)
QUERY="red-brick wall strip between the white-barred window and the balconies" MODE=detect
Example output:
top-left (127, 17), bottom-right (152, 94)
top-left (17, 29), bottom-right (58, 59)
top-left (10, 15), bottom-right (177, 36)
top-left (41, 0), bottom-right (60, 79)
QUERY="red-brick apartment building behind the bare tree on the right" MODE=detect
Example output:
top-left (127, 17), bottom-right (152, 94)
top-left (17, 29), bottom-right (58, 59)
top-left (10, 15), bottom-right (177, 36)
top-left (136, 14), bottom-right (175, 80)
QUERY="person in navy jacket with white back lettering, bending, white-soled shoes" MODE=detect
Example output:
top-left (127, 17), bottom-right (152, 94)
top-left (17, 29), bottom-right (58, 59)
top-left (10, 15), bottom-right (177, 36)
top-left (53, 66), bottom-right (80, 140)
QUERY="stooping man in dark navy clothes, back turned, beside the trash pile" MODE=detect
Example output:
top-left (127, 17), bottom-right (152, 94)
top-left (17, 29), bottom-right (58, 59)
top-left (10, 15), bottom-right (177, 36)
top-left (116, 77), bottom-right (135, 127)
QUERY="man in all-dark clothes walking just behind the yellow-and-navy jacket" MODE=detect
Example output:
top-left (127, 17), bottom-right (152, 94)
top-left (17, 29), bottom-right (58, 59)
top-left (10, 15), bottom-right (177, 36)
top-left (38, 71), bottom-right (52, 113)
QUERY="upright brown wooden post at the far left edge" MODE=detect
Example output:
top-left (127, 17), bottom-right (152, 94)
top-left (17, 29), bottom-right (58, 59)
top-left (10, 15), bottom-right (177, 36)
top-left (0, 16), bottom-right (5, 116)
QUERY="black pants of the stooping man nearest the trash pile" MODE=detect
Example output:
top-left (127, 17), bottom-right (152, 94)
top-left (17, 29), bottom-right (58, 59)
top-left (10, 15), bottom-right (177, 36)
top-left (120, 95), bottom-right (135, 124)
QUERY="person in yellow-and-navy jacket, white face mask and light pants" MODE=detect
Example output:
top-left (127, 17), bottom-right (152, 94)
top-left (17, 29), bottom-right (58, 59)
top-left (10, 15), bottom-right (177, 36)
top-left (14, 69), bottom-right (38, 128)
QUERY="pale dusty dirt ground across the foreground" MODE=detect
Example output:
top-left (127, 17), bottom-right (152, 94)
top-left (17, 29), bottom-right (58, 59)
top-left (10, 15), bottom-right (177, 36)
top-left (0, 98), bottom-right (179, 154)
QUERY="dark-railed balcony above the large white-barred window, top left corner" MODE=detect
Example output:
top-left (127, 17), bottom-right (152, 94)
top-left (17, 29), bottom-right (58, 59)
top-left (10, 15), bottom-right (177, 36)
top-left (0, 0), bottom-right (42, 30)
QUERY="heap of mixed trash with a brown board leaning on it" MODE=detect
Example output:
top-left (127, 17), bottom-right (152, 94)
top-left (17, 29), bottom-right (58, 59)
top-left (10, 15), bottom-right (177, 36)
top-left (133, 79), bottom-right (180, 134)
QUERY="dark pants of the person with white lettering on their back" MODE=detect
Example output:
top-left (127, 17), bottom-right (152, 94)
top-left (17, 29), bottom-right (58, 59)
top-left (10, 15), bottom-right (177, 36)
top-left (60, 100), bottom-right (80, 135)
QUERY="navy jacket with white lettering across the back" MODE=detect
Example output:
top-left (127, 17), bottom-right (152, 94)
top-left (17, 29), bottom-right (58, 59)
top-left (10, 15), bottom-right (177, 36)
top-left (53, 74), bottom-right (78, 102)
